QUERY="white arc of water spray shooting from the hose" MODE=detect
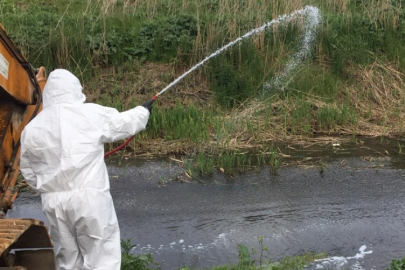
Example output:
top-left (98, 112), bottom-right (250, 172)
top-left (153, 6), bottom-right (321, 99)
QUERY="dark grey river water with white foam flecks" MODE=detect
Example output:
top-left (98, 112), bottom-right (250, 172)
top-left (8, 140), bottom-right (405, 270)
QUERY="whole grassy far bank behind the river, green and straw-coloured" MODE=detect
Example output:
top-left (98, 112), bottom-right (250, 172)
top-left (0, 0), bottom-right (405, 172)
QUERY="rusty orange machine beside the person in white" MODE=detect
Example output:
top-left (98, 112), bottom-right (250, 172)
top-left (0, 24), bottom-right (56, 270)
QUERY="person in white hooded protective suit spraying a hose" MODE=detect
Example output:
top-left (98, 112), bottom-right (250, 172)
top-left (20, 69), bottom-right (153, 270)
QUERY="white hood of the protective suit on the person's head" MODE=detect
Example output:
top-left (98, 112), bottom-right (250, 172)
top-left (43, 69), bottom-right (86, 108)
